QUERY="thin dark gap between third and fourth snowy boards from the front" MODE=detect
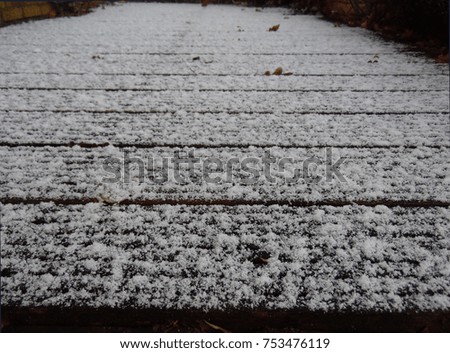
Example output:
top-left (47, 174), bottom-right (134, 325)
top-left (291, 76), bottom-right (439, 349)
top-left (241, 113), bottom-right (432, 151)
top-left (0, 109), bottom-right (449, 115)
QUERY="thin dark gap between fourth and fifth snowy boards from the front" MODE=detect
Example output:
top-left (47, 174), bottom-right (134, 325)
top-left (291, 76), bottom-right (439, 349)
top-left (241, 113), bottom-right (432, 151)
top-left (0, 87), bottom-right (449, 93)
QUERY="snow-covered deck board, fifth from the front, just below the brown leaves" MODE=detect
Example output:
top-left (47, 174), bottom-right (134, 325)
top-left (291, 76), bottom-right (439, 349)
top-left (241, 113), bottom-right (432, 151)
top-left (0, 72), bottom-right (448, 91)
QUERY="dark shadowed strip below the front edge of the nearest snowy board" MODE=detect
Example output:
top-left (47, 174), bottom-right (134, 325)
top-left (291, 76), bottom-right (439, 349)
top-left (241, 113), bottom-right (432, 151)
top-left (1, 306), bottom-right (450, 332)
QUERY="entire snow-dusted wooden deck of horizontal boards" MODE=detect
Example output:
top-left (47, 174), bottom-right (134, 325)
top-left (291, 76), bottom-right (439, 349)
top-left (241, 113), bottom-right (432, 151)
top-left (0, 4), bottom-right (450, 311)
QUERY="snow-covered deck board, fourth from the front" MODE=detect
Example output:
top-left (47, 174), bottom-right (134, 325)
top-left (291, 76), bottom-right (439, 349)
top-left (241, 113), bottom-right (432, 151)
top-left (0, 89), bottom-right (449, 114)
